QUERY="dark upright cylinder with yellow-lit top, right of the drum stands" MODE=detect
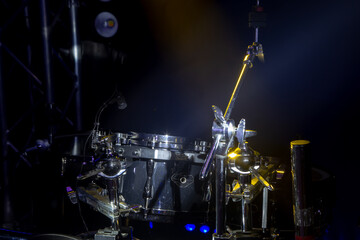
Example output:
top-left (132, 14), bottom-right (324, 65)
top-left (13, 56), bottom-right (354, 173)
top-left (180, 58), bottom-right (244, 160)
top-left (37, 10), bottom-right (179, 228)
top-left (291, 140), bottom-right (313, 239)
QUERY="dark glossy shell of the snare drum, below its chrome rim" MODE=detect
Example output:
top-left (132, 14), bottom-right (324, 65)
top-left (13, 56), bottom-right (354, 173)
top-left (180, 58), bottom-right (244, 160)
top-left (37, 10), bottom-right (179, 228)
top-left (121, 159), bottom-right (209, 219)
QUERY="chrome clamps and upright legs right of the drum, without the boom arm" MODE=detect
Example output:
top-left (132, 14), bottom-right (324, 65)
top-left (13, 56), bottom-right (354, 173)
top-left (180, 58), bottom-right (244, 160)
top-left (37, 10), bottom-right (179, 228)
top-left (200, 106), bottom-right (277, 239)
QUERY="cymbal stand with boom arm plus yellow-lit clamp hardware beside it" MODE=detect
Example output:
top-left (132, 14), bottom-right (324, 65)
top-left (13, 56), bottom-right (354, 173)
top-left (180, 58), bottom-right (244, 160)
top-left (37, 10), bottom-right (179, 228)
top-left (199, 0), bottom-right (284, 240)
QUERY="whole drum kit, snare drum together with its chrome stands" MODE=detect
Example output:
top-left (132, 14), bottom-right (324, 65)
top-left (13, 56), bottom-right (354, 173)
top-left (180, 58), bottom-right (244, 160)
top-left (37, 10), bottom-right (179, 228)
top-left (58, 2), bottom-right (290, 240)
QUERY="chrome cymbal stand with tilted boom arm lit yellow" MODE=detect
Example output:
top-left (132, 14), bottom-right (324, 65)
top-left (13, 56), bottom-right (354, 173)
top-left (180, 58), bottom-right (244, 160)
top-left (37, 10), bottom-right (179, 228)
top-left (199, 1), bottom-right (263, 240)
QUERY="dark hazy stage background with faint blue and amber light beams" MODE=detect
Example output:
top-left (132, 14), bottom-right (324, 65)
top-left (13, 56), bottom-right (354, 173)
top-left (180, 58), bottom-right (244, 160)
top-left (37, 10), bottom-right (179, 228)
top-left (1, 0), bottom-right (360, 239)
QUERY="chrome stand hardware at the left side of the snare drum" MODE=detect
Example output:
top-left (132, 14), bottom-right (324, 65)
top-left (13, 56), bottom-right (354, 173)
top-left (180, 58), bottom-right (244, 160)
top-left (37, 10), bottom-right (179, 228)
top-left (72, 151), bottom-right (142, 240)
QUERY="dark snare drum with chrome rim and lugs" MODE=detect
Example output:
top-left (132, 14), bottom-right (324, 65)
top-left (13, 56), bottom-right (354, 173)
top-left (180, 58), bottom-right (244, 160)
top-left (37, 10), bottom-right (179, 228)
top-left (114, 132), bottom-right (209, 221)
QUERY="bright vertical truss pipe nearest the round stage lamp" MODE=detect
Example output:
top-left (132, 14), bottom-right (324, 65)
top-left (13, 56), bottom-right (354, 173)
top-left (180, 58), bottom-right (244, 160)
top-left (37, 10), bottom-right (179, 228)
top-left (69, 0), bottom-right (83, 131)
